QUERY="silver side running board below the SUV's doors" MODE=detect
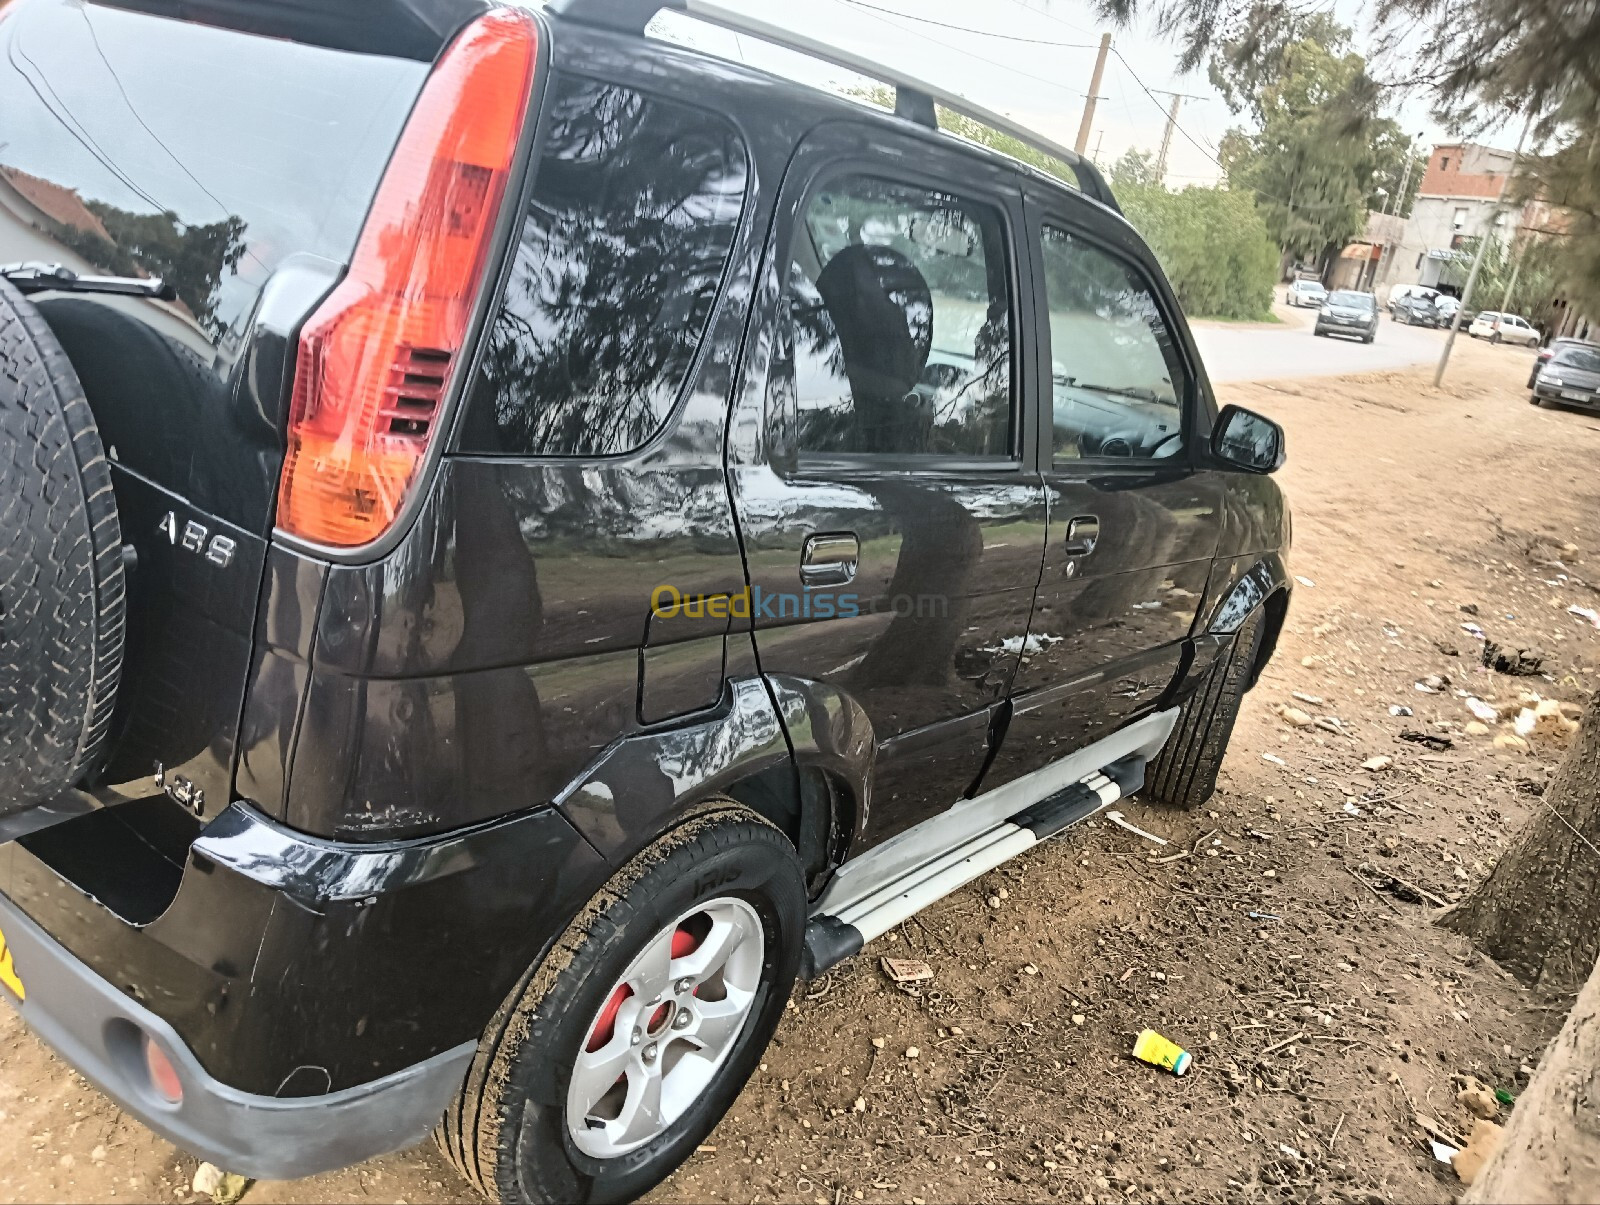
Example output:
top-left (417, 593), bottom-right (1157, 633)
top-left (800, 755), bottom-right (1146, 979)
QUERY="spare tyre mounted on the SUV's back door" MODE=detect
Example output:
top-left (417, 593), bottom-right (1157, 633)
top-left (0, 280), bottom-right (125, 816)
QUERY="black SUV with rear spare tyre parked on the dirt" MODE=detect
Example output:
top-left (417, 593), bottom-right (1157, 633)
top-left (0, 0), bottom-right (1290, 1200)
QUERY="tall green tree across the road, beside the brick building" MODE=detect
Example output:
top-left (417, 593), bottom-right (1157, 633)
top-left (1211, 13), bottom-right (1413, 258)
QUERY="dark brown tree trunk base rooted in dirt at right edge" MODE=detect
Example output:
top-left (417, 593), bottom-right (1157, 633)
top-left (1440, 695), bottom-right (1600, 985)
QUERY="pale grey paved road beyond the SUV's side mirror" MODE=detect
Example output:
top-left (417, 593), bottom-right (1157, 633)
top-left (1194, 304), bottom-right (1484, 381)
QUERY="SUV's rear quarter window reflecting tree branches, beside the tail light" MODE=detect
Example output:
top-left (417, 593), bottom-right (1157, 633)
top-left (462, 77), bottom-right (746, 456)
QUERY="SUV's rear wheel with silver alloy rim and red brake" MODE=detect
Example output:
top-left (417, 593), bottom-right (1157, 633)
top-left (435, 800), bottom-right (806, 1202)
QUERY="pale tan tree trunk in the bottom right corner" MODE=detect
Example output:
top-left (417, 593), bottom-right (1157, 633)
top-left (1462, 965), bottom-right (1600, 1205)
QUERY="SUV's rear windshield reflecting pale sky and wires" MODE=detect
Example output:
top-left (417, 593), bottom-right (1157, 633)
top-left (0, 0), bottom-right (427, 342)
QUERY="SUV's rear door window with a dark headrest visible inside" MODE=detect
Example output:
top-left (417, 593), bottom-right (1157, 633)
top-left (786, 176), bottom-right (1011, 456)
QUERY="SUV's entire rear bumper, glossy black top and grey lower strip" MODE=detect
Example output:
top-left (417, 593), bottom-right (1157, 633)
top-left (0, 800), bottom-right (606, 1178)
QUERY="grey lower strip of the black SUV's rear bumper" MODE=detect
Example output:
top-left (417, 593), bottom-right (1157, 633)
top-left (0, 896), bottom-right (477, 1179)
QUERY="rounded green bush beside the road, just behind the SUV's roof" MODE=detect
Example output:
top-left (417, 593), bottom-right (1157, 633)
top-left (1112, 150), bottom-right (1278, 320)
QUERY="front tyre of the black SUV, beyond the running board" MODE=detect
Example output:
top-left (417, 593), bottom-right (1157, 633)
top-left (1142, 608), bottom-right (1266, 808)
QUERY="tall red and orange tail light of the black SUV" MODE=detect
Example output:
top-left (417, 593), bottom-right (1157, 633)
top-left (278, 10), bottom-right (538, 547)
